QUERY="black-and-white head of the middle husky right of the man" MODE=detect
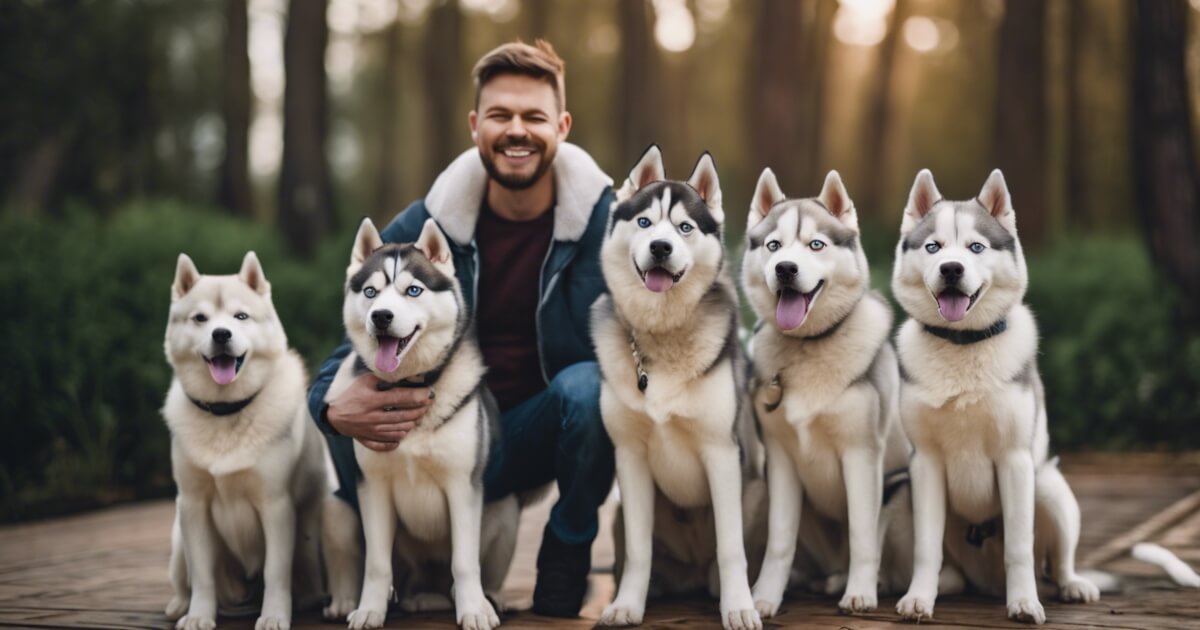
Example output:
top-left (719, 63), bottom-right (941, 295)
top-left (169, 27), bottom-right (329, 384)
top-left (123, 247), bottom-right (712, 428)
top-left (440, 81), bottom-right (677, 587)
top-left (600, 145), bottom-right (725, 321)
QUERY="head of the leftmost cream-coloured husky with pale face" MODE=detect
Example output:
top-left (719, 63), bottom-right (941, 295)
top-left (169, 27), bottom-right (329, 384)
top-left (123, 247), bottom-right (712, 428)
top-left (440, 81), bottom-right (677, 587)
top-left (164, 252), bottom-right (288, 400)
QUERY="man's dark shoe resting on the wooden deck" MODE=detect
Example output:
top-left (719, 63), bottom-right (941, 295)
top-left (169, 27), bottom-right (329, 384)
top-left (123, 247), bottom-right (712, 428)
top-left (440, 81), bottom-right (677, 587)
top-left (533, 524), bottom-right (592, 617)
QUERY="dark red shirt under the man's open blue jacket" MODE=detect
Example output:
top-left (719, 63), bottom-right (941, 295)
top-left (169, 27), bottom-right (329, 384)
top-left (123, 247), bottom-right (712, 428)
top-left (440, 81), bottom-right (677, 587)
top-left (468, 200), bottom-right (554, 410)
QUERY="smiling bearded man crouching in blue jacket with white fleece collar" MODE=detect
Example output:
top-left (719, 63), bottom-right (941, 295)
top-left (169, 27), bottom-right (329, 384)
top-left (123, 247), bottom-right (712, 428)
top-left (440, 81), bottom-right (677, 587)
top-left (308, 41), bottom-right (614, 617)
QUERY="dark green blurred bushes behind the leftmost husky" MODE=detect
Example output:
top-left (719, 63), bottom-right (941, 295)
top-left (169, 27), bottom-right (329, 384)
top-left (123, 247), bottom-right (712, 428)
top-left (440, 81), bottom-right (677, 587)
top-left (0, 203), bottom-right (350, 520)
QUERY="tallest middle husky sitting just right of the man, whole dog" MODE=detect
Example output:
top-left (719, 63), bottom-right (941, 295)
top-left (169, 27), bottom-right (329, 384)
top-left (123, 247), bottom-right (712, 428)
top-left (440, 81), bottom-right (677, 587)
top-left (592, 146), bottom-right (762, 629)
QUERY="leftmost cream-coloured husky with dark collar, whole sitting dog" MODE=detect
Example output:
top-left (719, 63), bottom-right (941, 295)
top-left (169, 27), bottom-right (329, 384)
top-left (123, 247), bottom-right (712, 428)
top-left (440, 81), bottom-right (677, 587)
top-left (162, 252), bottom-right (336, 630)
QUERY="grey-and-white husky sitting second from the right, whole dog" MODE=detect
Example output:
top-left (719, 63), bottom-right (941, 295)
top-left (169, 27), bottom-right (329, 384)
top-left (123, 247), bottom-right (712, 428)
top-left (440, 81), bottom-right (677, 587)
top-left (742, 168), bottom-right (912, 617)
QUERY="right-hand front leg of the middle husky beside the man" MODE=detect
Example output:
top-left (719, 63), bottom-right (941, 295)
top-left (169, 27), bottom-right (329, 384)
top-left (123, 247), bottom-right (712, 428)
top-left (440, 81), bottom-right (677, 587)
top-left (703, 444), bottom-right (762, 630)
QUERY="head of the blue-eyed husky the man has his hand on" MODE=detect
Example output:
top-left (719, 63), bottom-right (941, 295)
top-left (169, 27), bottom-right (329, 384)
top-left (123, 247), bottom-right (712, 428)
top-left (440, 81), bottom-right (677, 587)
top-left (342, 218), bottom-right (467, 380)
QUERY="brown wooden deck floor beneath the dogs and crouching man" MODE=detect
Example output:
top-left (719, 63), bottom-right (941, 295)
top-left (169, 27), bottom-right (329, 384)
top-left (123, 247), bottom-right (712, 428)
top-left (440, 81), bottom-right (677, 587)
top-left (0, 454), bottom-right (1200, 629)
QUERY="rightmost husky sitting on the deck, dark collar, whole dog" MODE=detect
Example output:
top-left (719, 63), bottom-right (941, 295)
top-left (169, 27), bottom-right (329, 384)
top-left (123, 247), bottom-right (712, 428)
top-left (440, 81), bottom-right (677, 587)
top-left (892, 170), bottom-right (1099, 624)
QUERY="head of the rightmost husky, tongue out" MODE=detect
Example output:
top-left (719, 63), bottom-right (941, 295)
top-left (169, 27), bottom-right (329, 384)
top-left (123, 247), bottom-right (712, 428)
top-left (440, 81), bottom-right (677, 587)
top-left (892, 169), bottom-right (1028, 329)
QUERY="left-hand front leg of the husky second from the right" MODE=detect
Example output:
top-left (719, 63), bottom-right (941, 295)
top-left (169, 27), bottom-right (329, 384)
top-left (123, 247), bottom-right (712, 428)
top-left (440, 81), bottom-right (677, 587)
top-left (754, 439), bottom-right (804, 617)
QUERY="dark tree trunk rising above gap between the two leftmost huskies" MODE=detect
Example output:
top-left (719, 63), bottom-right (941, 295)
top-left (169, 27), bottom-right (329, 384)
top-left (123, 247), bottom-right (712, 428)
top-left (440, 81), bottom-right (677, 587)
top-left (280, 0), bottom-right (334, 256)
